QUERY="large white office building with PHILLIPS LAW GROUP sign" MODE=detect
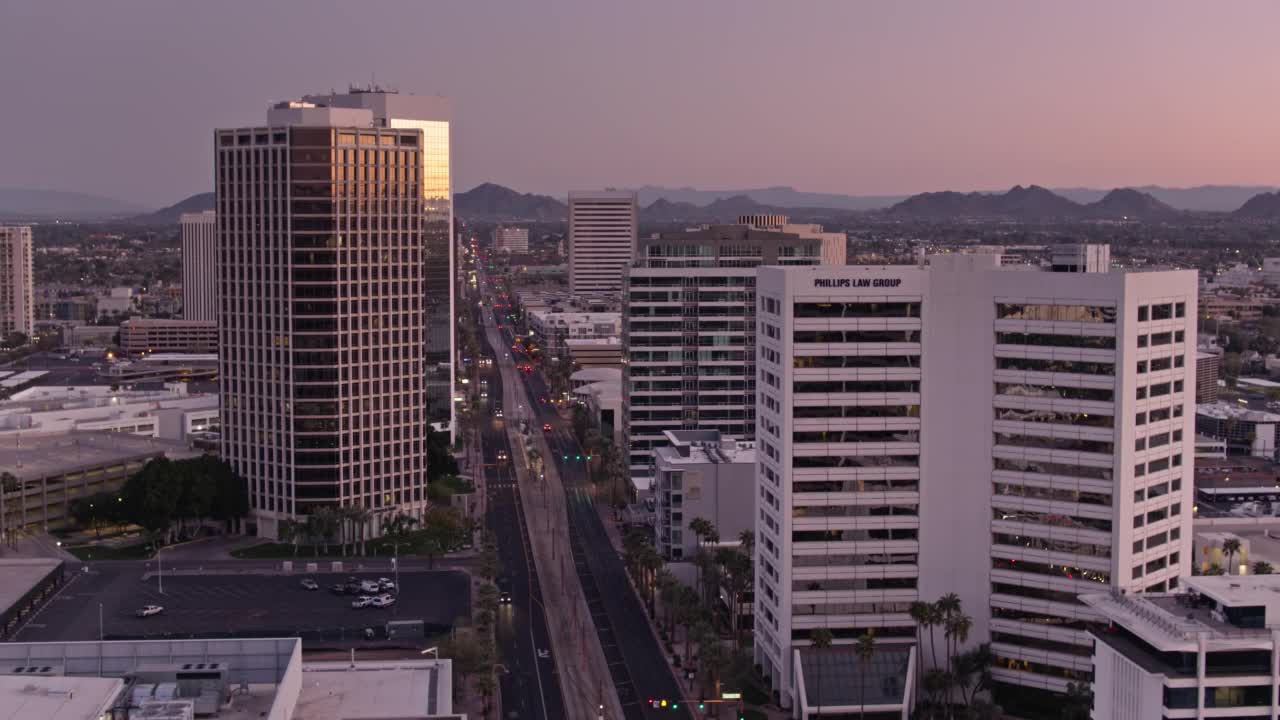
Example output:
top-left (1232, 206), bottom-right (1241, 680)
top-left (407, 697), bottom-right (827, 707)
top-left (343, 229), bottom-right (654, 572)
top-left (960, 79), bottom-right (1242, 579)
top-left (754, 254), bottom-right (1197, 703)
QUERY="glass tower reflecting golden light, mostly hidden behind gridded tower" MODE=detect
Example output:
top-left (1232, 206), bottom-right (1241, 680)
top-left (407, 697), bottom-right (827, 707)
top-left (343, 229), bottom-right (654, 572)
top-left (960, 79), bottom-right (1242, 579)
top-left (303, 87), bottom-right (458, 432)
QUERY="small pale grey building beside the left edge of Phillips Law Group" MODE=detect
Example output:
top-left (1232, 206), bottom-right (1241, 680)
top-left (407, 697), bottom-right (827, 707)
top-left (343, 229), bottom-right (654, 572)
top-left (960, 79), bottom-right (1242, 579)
top-left (653, 430), bottom-right (755, 560)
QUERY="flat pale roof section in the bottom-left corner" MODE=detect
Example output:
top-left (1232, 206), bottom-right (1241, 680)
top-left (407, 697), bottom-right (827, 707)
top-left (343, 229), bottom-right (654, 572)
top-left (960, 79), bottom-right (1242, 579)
top-left (0, 675), bottom-right (124, 720)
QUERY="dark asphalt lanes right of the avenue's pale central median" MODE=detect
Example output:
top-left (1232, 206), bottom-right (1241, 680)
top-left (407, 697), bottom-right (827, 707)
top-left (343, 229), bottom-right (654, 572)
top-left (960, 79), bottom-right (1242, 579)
top-left (503, 311), bottom-right (691, 720)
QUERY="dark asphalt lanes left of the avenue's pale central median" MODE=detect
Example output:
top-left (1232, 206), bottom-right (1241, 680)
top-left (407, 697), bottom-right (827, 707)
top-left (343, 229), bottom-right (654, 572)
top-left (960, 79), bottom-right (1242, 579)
top-left (477, 302), bottom-right (566, 720)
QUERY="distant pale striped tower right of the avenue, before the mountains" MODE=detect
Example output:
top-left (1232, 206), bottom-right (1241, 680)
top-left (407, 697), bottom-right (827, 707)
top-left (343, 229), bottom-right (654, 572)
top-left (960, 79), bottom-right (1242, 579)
top-left (568, 190), bottom-right (636, 295)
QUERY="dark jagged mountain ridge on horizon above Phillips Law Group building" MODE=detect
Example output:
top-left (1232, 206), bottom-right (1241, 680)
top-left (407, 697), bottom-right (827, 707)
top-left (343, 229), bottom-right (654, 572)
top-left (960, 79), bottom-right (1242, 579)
top-left (888, 184), bottom-right (1178, 220)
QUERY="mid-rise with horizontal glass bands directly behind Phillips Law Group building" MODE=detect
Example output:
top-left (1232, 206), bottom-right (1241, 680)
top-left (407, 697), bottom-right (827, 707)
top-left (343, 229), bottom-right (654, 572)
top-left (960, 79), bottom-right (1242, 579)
top-left (623, 225), bottom-right (822, 520)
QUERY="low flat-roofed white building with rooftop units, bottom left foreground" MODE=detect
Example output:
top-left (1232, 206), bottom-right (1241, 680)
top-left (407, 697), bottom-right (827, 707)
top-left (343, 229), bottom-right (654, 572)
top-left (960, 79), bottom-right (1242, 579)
top-left (0, 638), bottom-right (465, 720)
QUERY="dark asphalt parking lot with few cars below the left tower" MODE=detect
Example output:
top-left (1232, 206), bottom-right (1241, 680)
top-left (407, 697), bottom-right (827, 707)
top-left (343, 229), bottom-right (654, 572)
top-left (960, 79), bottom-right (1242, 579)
top-left (14, 571), bottom-right (471, 644)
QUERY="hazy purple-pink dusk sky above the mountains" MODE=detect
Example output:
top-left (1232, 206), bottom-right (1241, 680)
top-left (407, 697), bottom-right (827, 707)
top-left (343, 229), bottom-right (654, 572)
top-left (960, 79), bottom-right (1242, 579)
top-left (0, 0), bottom-right (1280, 206)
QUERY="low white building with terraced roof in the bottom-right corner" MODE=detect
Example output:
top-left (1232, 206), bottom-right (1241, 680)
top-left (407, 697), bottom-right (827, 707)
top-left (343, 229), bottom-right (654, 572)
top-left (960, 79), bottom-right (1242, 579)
top-left (1080, 575), bottom-right (1280, 720)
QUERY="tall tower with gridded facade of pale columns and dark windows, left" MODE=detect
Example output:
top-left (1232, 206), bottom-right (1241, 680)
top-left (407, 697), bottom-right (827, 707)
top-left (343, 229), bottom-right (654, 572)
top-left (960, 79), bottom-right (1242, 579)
top-left (214, 101), bottom-right (435, 537)
